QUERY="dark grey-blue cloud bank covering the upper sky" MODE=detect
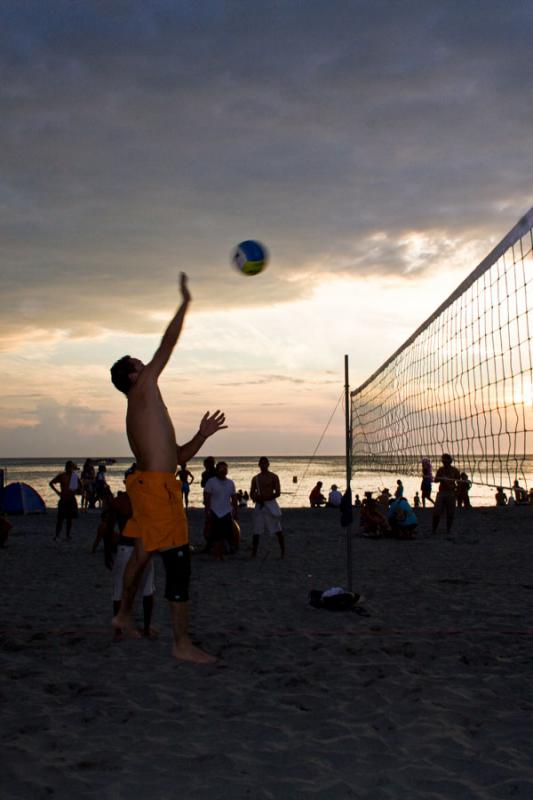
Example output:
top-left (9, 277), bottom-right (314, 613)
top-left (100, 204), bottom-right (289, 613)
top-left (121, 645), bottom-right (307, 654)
top-left (0, 2), bottom-right (533, 335)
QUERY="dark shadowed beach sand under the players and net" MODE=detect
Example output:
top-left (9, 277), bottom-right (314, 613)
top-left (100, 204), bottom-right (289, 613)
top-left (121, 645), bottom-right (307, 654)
top-left (0, 507), bottom-right (533, 800)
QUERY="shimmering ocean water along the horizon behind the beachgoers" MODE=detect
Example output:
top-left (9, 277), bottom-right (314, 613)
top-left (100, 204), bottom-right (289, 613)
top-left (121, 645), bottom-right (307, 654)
top-left (0, 456), bottom-right (533, 508)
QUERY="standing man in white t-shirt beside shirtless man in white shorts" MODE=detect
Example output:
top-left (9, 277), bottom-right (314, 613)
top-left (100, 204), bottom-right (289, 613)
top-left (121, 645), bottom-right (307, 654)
top-left (204, 461), bottom-right (239, 561)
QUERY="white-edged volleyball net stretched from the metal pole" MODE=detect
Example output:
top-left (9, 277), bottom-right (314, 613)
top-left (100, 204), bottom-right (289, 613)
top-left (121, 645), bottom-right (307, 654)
top-left (351, 208), bottom-right (533, 486)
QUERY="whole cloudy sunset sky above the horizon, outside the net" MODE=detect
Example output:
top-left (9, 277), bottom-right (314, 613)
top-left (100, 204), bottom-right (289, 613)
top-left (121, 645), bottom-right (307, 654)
top-left (0, 0), bottom-right (533, 457)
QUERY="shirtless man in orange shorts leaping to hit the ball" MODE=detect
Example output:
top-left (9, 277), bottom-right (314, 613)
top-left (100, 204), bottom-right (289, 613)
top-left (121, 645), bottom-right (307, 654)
top-left (111, 272), bottom-right (227, 664)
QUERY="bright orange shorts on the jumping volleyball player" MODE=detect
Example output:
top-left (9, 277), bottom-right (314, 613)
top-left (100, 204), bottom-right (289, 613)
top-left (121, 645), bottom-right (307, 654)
top-left (123, 471), bottom-right (189, 552)
